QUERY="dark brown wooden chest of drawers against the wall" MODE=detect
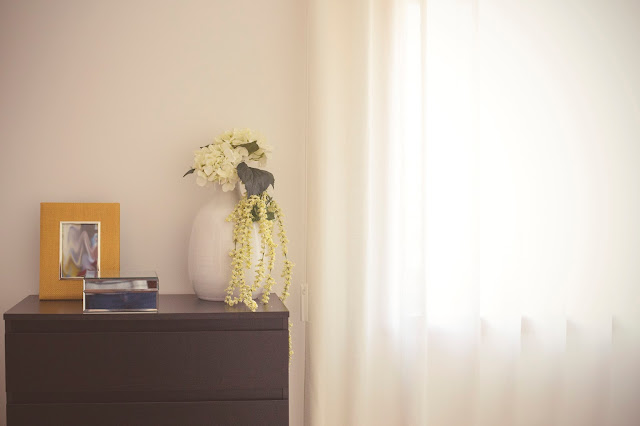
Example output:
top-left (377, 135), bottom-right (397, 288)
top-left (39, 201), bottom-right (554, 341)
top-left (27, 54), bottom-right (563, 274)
top-left (4, 295), bottom-right (289, 426)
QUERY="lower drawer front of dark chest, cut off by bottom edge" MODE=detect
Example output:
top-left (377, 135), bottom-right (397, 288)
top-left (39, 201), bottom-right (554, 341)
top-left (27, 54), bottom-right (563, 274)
top-left (7, 400), bottom-right (289, 426)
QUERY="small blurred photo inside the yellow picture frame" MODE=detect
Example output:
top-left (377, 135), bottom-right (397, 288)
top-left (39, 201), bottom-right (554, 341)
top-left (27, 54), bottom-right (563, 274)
top-left (60, 222), bottom-right (100, 279)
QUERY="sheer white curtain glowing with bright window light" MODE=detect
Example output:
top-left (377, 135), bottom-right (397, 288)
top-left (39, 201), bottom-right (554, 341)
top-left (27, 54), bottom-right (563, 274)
top-left (306, 0), bottom-right (640, 426)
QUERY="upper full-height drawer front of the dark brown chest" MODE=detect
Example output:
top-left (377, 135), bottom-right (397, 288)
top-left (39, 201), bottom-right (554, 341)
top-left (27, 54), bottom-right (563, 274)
top-left (5, 330), bottom-right (289, 393)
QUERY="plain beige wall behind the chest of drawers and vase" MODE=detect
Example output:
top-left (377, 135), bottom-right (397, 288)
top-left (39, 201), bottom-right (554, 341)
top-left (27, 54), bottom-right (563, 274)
top-left (0, 0), bottom-right (306, 425)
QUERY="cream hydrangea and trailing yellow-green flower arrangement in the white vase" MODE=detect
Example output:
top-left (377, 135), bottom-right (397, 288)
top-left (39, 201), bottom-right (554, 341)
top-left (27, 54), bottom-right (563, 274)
top-left (183, 129), bottom-right (294, 311)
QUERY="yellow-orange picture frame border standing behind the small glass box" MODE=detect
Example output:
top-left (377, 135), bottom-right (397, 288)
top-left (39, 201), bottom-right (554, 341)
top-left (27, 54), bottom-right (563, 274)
top-left (40, 203), bottom-right (120, 300)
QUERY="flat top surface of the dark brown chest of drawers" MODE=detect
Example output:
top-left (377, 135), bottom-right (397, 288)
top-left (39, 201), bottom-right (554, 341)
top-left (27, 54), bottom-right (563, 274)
top-left (4, 293), bottom-right (289, 320)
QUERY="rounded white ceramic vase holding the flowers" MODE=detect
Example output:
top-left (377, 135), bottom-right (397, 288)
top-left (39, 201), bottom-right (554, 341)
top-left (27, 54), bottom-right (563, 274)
top-left (189, 184), bottom-right (260, 301)
